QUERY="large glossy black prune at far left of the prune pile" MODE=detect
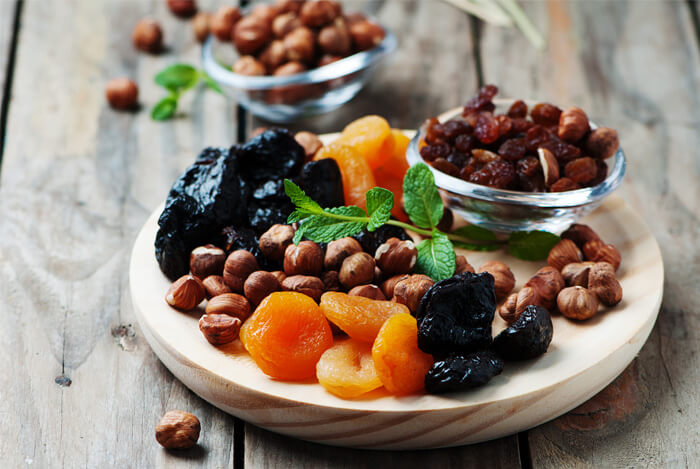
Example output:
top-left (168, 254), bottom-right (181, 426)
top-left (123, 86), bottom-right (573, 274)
top-left (155, 148), bottom-right (248, 280)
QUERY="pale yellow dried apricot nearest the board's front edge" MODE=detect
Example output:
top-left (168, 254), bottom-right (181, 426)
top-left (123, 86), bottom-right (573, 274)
top-left (316, 339), bottom-right (382, 399)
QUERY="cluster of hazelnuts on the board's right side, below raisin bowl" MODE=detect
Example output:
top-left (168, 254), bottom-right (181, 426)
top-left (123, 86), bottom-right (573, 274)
top-left (498, 224), bottom-right (622, 324)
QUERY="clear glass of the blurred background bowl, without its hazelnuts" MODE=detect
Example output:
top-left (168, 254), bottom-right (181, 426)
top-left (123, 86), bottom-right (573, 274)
top-left (202, 23), bottom-right (397, 123)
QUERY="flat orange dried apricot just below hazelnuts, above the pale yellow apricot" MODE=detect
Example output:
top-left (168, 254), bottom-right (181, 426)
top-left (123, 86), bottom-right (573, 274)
top-left (320, 292), bottom-right (409, 342)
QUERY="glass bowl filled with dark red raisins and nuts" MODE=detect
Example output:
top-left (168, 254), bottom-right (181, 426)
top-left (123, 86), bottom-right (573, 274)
top-left (406, 85), bottom-right (625, 233)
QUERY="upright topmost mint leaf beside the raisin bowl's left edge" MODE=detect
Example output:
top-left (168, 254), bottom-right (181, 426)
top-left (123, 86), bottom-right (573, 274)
top-left (403, 163), bottom-right (444, 229)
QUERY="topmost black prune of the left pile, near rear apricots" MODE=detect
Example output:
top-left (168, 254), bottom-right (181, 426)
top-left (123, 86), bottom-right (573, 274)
top-left (234, 129), bottom-right (306, 185)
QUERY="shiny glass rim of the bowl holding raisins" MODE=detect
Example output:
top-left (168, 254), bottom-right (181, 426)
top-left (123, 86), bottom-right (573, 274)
top-left (406, 98), bottom-right (627, 207)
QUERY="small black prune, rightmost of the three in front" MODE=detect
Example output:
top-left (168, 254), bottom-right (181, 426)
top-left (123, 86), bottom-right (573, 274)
top-left (493, 305), bottom-right (554, 360)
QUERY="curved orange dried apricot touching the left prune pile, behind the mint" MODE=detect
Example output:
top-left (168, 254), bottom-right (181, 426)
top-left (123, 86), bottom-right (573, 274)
top-left (314, 142), bottom-right (376, 208)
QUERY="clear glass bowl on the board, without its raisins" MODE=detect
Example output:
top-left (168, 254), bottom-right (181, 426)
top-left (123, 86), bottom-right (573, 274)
top-left (406, 99), bottom-right (626, 233)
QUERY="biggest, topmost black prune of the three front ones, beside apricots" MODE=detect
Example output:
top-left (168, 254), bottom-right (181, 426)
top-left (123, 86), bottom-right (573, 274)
top-left (415, 272), bottom-right (496, 356)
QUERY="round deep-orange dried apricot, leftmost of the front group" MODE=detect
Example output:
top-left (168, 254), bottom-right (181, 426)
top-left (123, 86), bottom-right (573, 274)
top-left (240, 292), bottom-right (333, 380)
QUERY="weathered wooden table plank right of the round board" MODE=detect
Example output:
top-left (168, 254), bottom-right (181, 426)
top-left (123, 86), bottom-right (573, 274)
top-left (482, 1), bottom-right (700, 467)
